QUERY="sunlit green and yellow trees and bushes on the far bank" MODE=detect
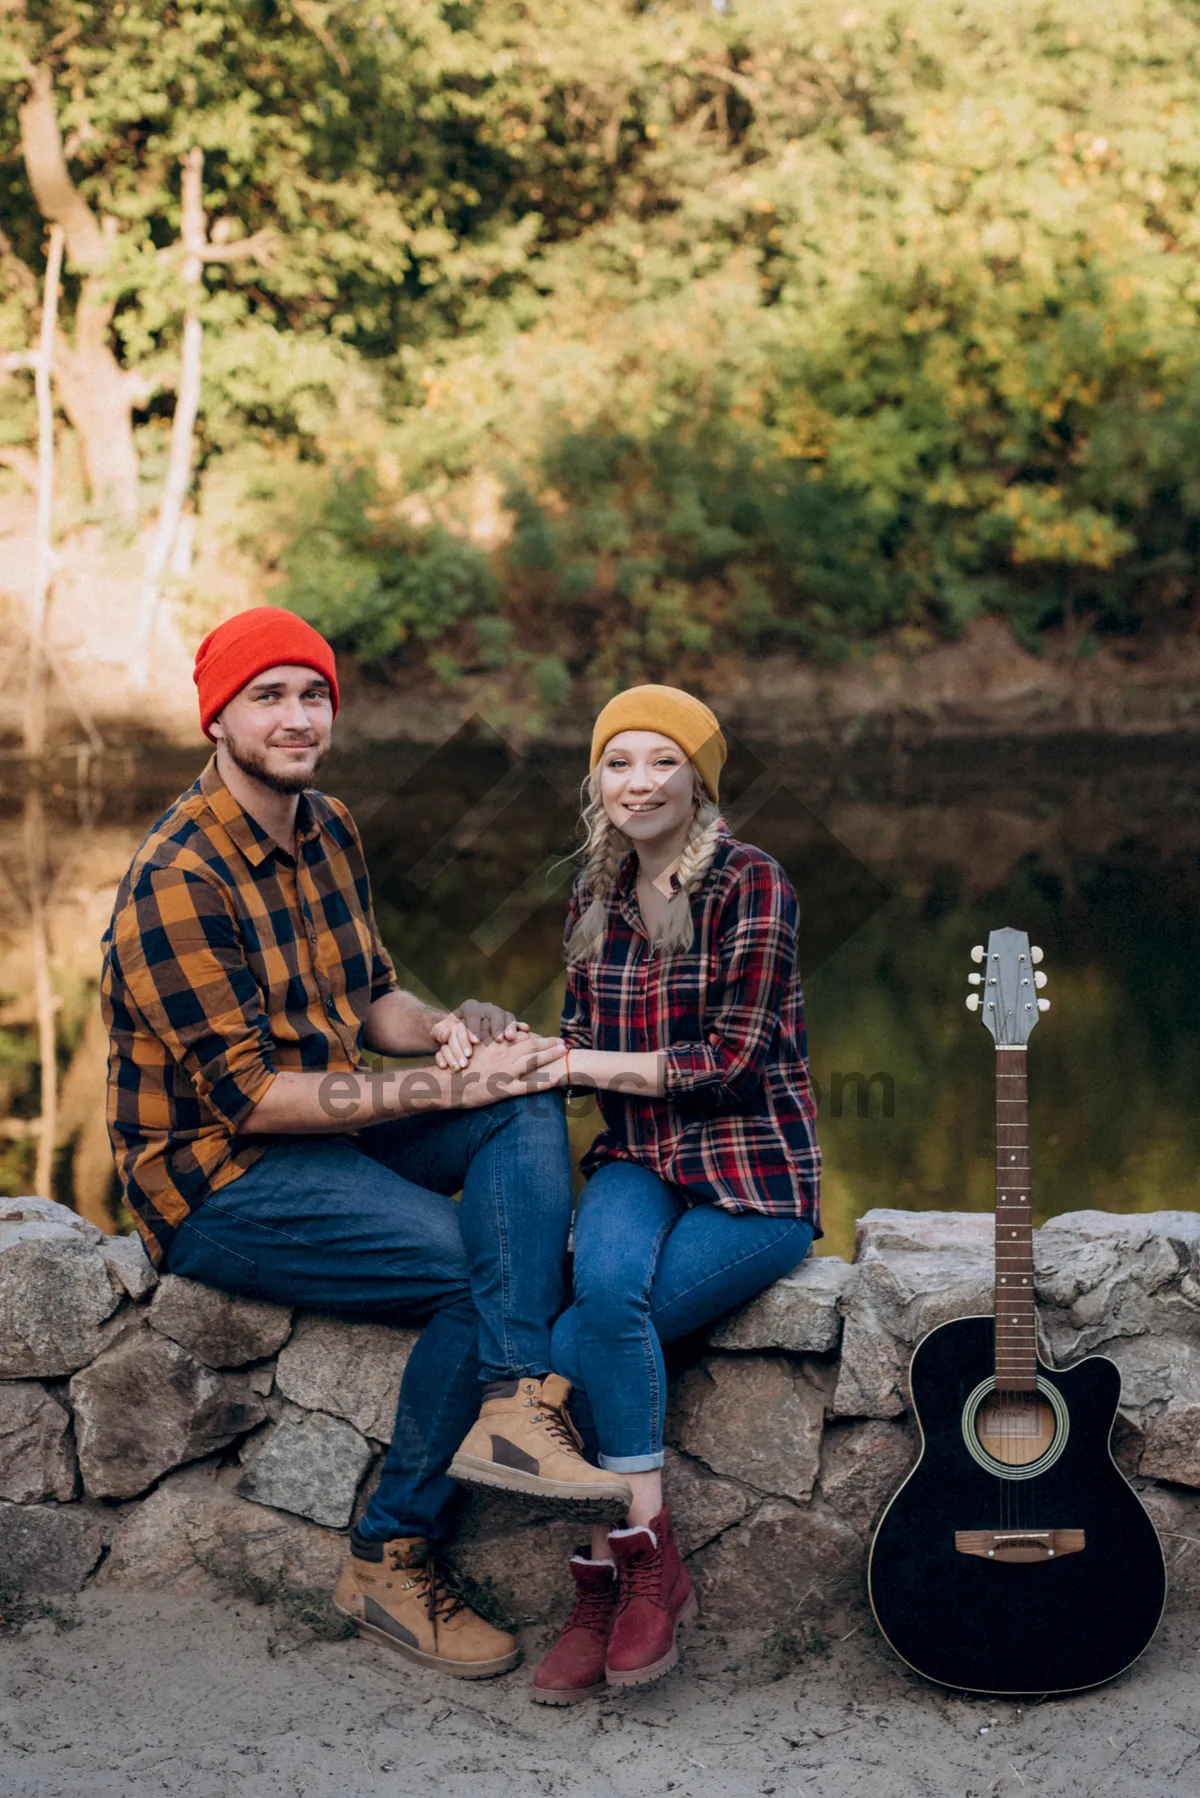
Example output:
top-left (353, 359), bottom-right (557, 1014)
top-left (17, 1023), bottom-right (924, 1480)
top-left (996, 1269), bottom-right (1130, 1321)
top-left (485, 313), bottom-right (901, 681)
top-left (0, 0), bottom-right (1200, 676)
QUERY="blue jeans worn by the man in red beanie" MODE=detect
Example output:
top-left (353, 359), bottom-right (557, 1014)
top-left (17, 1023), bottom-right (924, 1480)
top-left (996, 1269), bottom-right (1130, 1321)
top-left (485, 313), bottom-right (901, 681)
top-left (167, 1093), bottom-right (572, 1541)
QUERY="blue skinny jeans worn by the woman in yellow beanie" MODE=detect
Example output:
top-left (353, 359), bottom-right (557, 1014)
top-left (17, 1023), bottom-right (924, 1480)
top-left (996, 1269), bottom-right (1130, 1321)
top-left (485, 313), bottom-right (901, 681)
top-left (551, 1162), bottom-right (813, 1473)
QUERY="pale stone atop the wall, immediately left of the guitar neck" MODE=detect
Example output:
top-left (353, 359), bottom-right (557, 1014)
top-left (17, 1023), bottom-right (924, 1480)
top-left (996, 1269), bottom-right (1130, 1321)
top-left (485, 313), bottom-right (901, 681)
top-left (833, 1251), bottom-right (995, 1417)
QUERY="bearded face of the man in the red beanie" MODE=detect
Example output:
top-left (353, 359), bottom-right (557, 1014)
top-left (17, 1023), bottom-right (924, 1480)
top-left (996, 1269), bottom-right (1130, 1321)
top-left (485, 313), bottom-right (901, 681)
top-left (212, 662), bottom-right (333, 793)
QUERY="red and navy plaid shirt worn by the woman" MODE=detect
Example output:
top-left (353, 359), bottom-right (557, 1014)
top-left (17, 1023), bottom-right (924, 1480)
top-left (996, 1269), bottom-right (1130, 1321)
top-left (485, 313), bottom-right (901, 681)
top-left (561, 829), bottom-right (820, 1235)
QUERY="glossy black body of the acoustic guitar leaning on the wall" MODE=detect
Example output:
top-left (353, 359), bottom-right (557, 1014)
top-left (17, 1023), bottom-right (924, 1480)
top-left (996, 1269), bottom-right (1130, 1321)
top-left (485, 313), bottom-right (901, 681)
top-left (867, 1318), bottom-right (1166, 1694)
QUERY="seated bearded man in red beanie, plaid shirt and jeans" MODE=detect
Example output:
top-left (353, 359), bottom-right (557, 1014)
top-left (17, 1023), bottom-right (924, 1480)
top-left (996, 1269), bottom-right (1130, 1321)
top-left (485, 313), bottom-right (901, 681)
top-left (103, 606), bottom-right (628, 1678)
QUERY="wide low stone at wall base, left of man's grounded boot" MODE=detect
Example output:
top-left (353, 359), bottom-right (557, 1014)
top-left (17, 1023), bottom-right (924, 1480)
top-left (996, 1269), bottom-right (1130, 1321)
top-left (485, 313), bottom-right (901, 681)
top-left (95, 1465), bottom-right (347, 1597)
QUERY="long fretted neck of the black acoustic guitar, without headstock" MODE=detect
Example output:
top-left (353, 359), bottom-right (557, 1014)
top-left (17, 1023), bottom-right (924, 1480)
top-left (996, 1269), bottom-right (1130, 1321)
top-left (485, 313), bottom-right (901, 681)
top-left (995, 1048), bottom-right (1038, 1392)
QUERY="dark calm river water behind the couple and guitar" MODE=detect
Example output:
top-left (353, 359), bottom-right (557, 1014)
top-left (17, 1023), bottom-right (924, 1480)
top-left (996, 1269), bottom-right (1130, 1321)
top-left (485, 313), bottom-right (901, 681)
top-left (0, 728), bottom-right (1200, 1253)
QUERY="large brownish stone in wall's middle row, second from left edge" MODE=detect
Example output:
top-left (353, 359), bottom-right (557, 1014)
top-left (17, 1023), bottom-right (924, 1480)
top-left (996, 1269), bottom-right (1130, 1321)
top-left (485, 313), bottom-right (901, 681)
top-left (70, 1329), bottom-right (266, 1498)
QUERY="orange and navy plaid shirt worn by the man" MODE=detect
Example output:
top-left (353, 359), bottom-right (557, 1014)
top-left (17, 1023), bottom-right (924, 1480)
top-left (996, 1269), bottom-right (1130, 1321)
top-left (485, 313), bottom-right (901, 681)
top-left (101, 757), bottom-right (398, 1260)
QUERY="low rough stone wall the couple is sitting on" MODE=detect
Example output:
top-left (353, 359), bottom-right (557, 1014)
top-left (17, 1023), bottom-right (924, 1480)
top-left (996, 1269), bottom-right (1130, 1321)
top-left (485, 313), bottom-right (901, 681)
top-left (0, 1199), bottom-right (1200, 1627)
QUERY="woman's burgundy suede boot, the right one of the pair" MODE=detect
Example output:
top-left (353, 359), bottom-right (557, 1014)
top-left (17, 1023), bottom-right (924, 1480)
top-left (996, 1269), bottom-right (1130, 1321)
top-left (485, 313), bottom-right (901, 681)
top-left (604, 1505), bottom-right (700, 1685)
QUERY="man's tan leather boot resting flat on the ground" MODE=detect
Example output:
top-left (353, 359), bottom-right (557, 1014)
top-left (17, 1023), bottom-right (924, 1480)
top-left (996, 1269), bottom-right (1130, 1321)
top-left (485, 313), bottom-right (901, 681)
top-left (333, 1535), bottom-right (520, 1679)
